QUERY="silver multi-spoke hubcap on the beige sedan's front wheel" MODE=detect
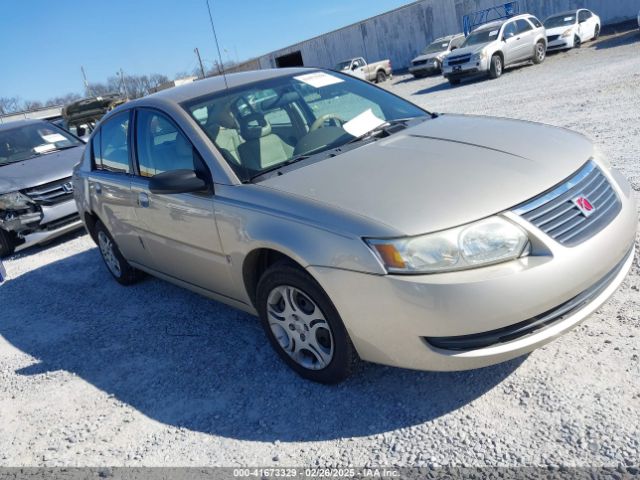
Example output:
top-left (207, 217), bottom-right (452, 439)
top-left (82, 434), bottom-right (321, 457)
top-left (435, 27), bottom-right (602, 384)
top-left (267, 285), bottom-right (334, 370)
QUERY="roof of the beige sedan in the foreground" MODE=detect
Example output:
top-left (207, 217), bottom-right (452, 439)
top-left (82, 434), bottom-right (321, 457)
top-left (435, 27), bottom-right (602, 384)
top-left (144, 68), bottom-right (317, 105)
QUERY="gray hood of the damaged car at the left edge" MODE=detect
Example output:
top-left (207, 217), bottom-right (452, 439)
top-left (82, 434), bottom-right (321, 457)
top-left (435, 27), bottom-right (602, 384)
top-left (0, 146), bottom-right (84, 193)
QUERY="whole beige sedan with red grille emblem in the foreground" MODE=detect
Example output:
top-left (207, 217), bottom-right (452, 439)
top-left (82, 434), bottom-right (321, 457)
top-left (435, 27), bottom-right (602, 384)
top-left (73, 69), bottom-right (637, 383)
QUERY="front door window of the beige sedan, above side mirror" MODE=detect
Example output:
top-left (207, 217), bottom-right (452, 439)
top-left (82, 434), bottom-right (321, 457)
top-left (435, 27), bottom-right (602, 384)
top-left (136, 109), bottom-right (196, 177)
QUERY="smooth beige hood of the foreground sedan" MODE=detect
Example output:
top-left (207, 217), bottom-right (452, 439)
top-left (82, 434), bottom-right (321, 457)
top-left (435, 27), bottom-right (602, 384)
top-left (259, 115), bottom-right (594, 235)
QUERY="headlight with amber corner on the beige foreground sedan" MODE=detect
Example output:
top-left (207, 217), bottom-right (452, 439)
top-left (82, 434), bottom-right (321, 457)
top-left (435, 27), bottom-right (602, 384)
top-left (365, 217), bottom-right (529, 273)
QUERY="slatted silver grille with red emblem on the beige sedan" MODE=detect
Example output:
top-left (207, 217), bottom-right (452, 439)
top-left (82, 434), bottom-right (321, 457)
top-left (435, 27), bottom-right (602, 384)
top-left (514, 161), bottom-right (622, 247)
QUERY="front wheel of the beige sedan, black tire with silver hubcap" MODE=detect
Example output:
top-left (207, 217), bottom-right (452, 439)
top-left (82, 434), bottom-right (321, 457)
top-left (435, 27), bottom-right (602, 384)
top-left (256, 262), bottom-right (358, 384)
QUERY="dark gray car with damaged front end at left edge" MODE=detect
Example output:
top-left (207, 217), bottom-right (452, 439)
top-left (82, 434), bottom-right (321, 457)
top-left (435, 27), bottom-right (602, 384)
top-left (0, 120), bottom-right (84, 257)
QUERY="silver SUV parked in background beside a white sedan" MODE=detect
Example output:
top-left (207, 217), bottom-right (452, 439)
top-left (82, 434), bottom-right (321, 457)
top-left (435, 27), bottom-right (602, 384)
top-left (442, 14), bottom-right (547, 85)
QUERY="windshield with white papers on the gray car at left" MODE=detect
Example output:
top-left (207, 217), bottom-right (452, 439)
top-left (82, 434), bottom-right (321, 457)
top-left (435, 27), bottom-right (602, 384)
top-left (0, 122), bottom-right (84, 166)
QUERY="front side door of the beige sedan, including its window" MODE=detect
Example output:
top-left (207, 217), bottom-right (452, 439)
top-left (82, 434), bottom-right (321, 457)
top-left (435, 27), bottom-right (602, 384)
top-left (131, 108), bottom-right (234, 296)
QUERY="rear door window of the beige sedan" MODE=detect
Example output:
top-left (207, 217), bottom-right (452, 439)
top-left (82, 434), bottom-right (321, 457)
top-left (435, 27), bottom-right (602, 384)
top-left (94, 110), bottom-right (129, 173)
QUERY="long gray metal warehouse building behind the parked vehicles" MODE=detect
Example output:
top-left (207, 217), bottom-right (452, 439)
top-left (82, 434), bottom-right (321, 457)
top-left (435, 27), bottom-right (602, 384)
top-left (233, 0), bottom-right (640, 71)
